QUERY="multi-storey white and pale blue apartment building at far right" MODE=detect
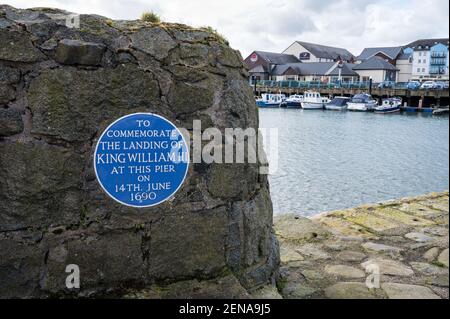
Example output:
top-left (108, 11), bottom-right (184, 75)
top-left (405, 38), bottom-right (449, 81)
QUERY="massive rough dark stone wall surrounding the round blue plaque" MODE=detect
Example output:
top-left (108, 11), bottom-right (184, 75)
top-left (0, 5), bottom-right (279, 298)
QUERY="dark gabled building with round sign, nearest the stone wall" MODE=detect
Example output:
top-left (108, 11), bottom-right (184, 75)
top-left (245, 51), bottom-right (300, 83)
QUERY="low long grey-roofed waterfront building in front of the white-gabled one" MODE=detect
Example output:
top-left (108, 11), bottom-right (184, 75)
top-left (271, 62), bottom-right (359, 83)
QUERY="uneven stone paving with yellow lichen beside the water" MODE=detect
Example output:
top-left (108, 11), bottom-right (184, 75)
top-left (272, 192), bottom-right (449, 299)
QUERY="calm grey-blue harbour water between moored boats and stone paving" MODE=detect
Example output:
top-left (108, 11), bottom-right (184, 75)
top-left (260, 109), bottom-right (449, 216)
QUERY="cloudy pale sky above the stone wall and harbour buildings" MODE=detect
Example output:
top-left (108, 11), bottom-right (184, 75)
top-left (4, 0), bottom-right (449, 58)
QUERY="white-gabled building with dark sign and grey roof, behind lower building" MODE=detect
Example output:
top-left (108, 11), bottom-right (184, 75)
top-left (283, 41), bottom-right (356, 63)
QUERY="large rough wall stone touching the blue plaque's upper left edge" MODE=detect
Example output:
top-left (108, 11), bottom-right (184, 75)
top-left (27, 64), bottom-right (161, 141)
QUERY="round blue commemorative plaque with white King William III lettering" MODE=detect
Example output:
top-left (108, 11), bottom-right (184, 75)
top-left (94, 113), bottom-right (189, 207)
